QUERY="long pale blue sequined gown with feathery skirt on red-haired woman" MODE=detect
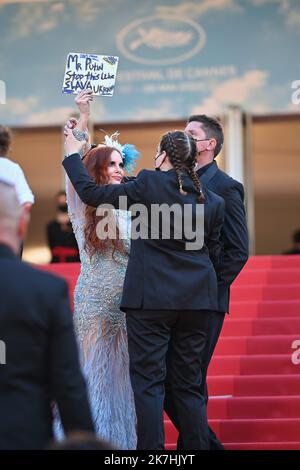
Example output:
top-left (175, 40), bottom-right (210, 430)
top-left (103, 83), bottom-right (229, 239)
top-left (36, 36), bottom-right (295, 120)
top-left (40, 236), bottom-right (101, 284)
top-left (67, 180), bottom-right (136, 449)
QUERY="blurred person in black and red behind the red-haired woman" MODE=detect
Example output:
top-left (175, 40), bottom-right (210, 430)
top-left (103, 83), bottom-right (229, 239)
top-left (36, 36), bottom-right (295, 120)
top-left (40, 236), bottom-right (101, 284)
top-left (47, 191), bottom-right (80, 263)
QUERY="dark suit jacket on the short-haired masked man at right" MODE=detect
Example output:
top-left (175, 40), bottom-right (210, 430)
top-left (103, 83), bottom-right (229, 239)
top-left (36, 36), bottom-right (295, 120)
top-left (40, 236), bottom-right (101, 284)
top-left (200, 161), bottom-right (249, 312)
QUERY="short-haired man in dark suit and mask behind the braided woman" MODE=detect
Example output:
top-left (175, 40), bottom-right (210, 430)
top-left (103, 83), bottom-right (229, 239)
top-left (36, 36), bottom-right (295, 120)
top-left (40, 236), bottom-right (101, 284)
top-left (165, 115), bottom-right (248, 450)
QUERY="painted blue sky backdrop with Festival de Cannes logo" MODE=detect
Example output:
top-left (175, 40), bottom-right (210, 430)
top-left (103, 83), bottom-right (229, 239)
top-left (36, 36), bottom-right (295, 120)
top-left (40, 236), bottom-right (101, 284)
top-left (0, 0), bottom-right (300, 126)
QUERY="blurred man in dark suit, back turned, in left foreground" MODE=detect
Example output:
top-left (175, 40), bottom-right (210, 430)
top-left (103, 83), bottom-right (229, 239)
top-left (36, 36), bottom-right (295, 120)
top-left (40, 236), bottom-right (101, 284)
top-left (0, 176), bottom-right (94, 450)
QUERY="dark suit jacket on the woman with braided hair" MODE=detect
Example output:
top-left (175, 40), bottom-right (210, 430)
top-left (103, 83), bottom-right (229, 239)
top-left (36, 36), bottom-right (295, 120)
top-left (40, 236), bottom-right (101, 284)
top-left (63, 154), bottom-right (224, 310)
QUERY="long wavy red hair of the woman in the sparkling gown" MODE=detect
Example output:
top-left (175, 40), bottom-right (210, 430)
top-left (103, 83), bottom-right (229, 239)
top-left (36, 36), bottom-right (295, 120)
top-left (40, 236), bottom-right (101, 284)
top-left (83, 146), bottom-right (124, 258)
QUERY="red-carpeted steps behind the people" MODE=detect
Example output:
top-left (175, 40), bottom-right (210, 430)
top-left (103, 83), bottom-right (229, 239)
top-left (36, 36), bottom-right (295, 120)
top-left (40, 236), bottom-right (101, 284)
top-left (38, 256), bottom-right (300, 450)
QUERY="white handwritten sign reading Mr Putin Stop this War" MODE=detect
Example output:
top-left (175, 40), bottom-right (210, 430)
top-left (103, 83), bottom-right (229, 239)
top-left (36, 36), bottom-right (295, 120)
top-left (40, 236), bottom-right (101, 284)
top-left (63, 52), bottom-right (119, 96)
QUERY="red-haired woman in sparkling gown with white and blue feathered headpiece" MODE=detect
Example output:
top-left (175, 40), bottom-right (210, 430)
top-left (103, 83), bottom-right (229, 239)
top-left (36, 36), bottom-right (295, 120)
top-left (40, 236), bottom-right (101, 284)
top-left (63, 127), bottom-right (138, 449)
